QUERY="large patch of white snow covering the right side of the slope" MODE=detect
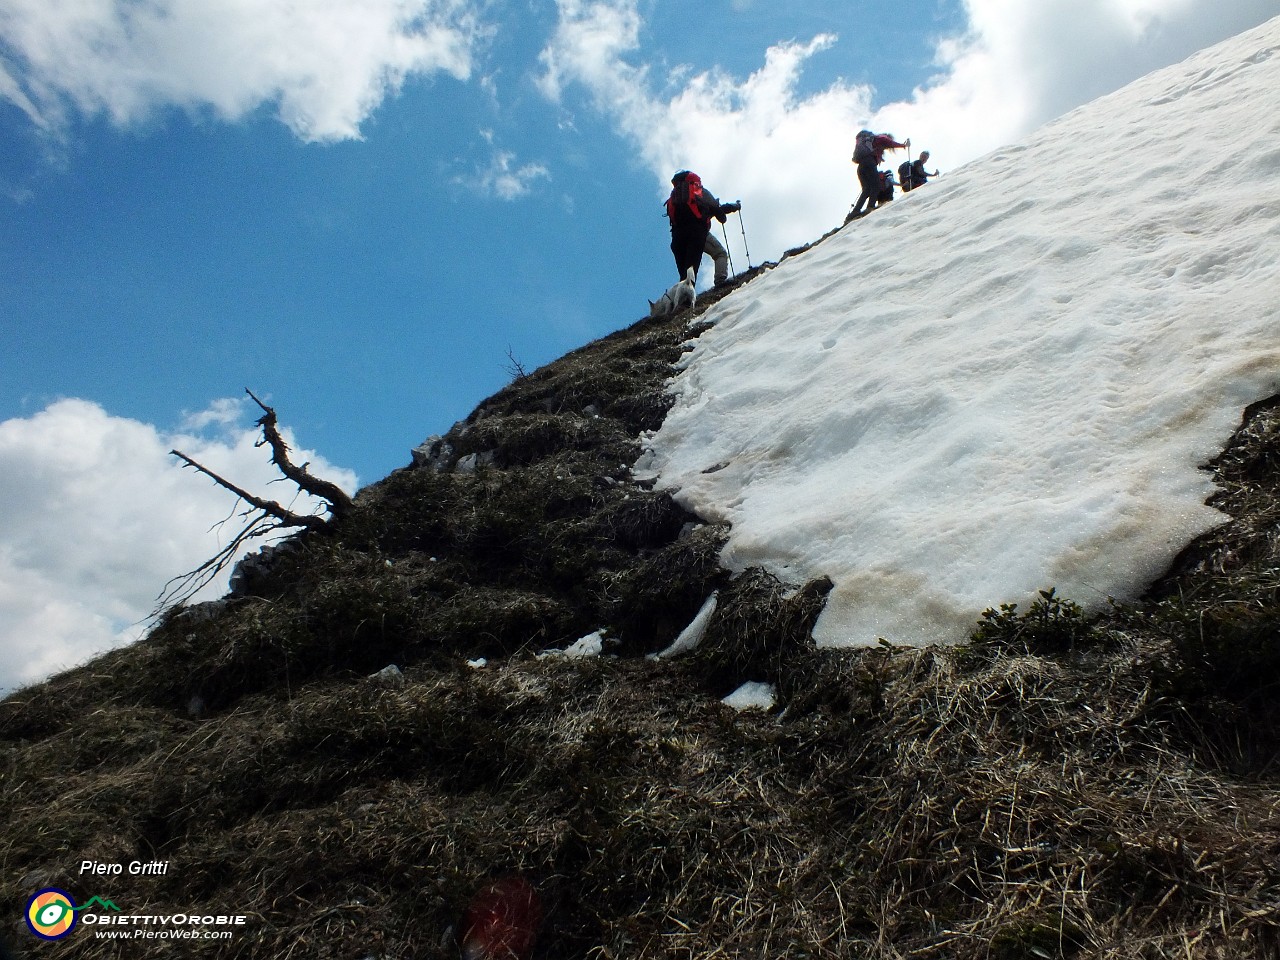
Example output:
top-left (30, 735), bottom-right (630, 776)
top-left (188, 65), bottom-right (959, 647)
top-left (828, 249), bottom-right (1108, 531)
top-left (643, 18), bottom-right (1280, 645)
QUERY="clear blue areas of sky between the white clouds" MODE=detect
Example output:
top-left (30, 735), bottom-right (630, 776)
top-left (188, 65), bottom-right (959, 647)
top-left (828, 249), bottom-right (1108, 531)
top-left (0, 3), bottom-right (960, 481)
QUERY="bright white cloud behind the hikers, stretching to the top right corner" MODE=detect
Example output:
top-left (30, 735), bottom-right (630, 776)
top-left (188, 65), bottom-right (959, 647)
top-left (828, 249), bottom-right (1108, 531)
top-left (539, 0), bottom-right (1275, 261)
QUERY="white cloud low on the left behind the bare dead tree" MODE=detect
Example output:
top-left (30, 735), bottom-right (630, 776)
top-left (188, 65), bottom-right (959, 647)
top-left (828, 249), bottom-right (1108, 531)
top-left (0, 399), bottom-right (356, 690)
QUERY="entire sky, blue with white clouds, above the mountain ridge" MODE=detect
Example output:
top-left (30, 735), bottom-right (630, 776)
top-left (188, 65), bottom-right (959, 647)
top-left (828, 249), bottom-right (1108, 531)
top-left (0, 0), bottom-right (1277, 691)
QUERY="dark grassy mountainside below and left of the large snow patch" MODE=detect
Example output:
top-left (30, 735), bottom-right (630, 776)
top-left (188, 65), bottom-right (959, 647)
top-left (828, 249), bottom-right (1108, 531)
top-left (0, 257), bottom-right (1280, 960)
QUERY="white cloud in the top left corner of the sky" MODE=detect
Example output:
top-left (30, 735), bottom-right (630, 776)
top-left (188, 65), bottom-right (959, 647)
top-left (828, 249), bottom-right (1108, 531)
top-left (0, 0), bottom-right (486, 141)
